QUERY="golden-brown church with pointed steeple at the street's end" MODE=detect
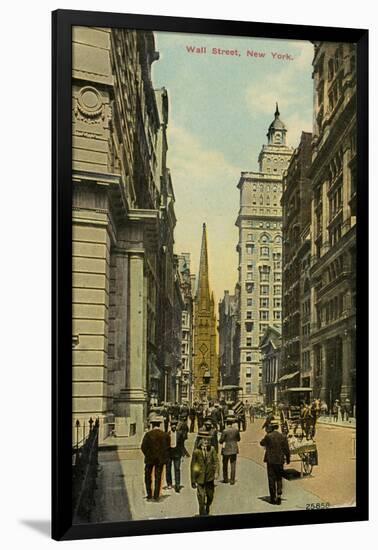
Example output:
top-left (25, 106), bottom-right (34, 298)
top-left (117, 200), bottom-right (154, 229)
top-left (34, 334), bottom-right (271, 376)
top-left (193, 224), bottom-right (219, 401)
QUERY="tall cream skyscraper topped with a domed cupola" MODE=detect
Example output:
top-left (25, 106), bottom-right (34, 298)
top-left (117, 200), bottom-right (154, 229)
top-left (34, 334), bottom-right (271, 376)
top-left (236, 106), bottom-right (292, 402)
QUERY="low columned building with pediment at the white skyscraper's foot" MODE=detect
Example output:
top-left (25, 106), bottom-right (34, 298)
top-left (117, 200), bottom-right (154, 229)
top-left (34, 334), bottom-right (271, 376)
top-left (260, 326), bottom-right (281, 407)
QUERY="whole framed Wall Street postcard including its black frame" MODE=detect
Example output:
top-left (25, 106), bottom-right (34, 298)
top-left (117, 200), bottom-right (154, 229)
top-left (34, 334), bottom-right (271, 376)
top-left (53, 10), bottom-right (368, 540)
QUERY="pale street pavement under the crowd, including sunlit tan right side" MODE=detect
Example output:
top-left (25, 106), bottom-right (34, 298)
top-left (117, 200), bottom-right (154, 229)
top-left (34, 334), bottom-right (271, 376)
top-left (92, 419), bottom-right (355, 522)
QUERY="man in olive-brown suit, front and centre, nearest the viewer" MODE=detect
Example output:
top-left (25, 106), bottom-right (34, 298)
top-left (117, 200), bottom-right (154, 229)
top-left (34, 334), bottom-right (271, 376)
top-left (190, 430), bottom-right (219, 516)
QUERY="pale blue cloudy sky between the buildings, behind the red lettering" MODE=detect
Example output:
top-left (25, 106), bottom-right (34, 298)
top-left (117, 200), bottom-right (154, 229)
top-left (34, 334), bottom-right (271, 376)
top-left (152, 32), bottom-right (313, 301)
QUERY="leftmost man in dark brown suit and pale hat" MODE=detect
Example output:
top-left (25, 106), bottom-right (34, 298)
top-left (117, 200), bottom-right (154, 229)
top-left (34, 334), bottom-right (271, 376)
top-left (141, 416), bottom-right (169, 500)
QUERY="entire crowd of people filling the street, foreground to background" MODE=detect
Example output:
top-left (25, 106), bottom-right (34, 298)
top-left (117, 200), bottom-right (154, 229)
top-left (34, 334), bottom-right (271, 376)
top-left (141, 399), bottom-right (350, 515)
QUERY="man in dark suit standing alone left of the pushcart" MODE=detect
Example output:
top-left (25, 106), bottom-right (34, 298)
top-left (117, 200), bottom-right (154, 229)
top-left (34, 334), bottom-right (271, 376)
top-left (260, 421), bottom-right (290, 504)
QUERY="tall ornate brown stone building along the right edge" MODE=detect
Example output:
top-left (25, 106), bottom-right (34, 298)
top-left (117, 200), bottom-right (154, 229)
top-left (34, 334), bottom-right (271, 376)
top-left (310, 42), bottom-right (356, 405)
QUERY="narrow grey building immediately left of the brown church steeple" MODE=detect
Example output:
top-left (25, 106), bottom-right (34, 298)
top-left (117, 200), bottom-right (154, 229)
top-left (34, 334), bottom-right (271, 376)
top-left (178, 252), bottom-right (194, 403)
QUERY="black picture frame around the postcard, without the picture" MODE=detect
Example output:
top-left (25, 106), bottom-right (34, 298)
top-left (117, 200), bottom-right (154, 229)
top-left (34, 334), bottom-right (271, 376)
top-left (52, 10), bottom-right (368, 540)
